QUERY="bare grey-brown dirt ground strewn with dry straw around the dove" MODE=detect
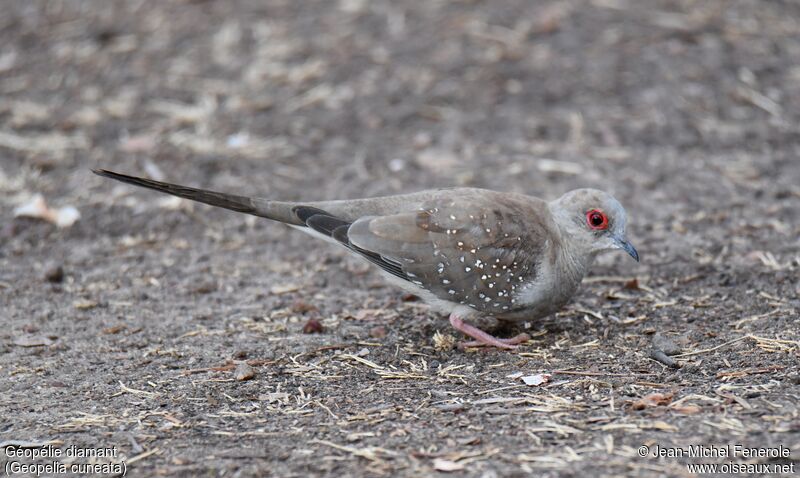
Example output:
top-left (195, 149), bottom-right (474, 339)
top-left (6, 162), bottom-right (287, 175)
top-left (0, 0), bottom-right (800, 477)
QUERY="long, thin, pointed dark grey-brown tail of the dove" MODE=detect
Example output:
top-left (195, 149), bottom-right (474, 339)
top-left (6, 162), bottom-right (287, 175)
top-left (92, 169), bottom-right (302, 225)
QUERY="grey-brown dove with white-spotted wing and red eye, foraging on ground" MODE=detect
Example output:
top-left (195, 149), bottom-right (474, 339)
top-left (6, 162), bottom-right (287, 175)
top-left (93, 169), bottom-right (639, 349)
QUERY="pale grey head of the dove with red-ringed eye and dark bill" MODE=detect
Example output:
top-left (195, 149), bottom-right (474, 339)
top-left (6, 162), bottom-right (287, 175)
top-left (550, 189), bottom-right (639, 262)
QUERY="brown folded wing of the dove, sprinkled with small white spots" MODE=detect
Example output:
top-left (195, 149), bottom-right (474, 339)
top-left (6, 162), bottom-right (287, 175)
top-left (340, 192), bottom-right (552, 314)
